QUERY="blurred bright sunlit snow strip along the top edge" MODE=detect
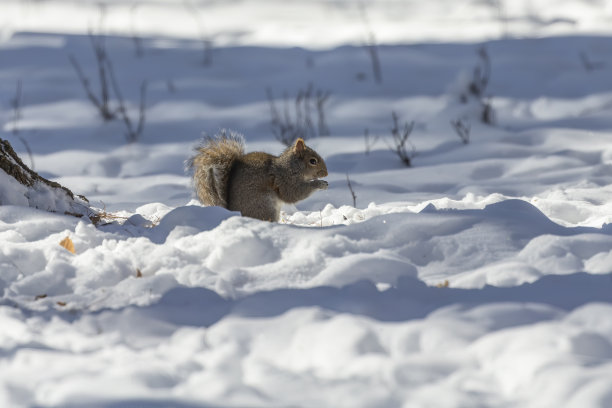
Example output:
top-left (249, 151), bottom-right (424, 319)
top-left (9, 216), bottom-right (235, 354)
top-left (0, 0), bottom-right (612, 48)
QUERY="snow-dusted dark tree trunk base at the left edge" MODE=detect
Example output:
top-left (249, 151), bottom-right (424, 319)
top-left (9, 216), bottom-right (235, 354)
top-left (0, 138), bottom-right (95, 218)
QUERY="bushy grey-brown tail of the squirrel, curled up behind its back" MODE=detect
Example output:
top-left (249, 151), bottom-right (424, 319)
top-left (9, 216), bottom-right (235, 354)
top-left (187, 130), bottom-right (244, 208)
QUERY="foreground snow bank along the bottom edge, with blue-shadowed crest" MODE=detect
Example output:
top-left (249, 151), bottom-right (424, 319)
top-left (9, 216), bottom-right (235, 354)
top-left (0, 274), bottom-right (612, 407)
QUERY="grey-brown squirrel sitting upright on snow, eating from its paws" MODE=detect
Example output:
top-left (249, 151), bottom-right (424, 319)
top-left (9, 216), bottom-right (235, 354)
top-left (187, 130), bottom-right (328, 221)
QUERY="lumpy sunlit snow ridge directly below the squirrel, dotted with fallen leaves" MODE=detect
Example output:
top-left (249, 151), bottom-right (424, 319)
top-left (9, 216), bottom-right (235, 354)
top-left (1, 200), bottom-right (612, 309)
